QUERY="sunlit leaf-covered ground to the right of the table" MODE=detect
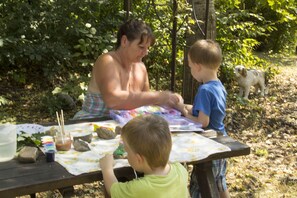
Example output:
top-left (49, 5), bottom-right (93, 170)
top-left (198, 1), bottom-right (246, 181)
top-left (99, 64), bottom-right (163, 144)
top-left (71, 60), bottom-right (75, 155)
top-left (227, 59), bottom-right (297, 198)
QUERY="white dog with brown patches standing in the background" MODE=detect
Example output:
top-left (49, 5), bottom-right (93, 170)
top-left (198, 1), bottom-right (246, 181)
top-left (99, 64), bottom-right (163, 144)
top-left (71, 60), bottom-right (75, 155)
top-left (234, 65), bottom-right (267, 99)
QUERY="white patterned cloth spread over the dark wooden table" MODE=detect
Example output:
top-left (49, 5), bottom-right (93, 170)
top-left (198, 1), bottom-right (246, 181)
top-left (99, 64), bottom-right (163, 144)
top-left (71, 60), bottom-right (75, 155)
top-left (16, 120), bottom-right (230, 175)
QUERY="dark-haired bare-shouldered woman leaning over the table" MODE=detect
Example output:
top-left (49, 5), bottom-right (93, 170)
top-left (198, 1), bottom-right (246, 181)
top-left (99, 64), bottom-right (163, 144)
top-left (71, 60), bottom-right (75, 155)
top-left (74, 20), bottom-right (182, 119)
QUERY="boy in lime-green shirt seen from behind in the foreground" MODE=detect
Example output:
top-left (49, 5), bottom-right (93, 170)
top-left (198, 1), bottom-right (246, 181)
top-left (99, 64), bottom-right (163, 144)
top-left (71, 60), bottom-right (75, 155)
top-left (100, 115), bottom-right (189, 198)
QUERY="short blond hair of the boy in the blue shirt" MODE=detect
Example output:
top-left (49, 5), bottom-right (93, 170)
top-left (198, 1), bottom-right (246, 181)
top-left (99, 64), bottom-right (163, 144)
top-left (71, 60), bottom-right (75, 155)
top-left (188, 39), bottom-right (222, 69)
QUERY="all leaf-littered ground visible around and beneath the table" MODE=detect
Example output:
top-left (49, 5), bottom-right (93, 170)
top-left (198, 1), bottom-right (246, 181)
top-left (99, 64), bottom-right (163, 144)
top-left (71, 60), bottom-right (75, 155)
top-left (0, 56), bottom-right (297, 198)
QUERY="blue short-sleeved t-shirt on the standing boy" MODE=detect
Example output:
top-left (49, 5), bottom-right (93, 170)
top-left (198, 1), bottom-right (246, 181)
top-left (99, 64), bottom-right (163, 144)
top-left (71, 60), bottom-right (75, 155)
top-left (192, 80), bottom-right (227, 135)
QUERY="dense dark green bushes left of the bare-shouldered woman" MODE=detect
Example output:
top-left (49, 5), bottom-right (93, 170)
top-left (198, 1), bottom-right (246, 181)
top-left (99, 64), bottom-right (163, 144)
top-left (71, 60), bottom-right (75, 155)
top-left (0, 0), bottom-right (122, 92)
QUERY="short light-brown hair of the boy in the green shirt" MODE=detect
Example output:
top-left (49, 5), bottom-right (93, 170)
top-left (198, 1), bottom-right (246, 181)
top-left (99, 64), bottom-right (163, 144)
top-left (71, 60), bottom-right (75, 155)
top-left (121, 115), bottom-right (172, 169)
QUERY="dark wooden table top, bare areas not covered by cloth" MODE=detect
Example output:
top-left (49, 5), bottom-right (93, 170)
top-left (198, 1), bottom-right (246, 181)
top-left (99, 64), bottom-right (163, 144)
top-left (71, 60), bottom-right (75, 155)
top-left (0, 119), bottom-right (250, 197)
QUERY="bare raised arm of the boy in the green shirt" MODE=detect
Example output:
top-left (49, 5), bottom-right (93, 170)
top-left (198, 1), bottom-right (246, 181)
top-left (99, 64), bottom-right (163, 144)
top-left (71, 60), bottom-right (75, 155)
top-left (100, 154), bottom-right (118, 195)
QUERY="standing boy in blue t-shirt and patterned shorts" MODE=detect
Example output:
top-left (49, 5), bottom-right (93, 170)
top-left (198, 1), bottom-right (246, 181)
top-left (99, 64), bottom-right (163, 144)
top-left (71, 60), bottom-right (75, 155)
top-left (178, 40), bottom-right (230, 198)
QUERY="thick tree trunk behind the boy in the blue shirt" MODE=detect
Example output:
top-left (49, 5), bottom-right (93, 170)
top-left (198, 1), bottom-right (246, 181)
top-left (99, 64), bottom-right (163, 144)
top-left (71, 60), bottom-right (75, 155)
top-left (182, 0), bottom-right (216, 104)
